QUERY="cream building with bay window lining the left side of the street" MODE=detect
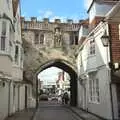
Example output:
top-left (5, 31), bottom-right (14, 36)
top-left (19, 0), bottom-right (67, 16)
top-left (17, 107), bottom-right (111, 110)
top-left (0, 0), bottom-right (33, 120)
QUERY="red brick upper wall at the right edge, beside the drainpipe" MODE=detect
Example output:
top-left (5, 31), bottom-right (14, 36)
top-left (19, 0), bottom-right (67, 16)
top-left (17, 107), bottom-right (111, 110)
top-left (109, 23), bottom-right (120, 62)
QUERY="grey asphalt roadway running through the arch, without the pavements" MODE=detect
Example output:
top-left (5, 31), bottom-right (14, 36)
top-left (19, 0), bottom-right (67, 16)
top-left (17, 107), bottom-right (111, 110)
top-left (33, 101), bottom-right (82, 120)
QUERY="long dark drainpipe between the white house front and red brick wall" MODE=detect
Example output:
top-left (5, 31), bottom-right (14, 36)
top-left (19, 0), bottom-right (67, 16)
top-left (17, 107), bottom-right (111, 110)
top-left (108, 24), bottom-right (115, 120)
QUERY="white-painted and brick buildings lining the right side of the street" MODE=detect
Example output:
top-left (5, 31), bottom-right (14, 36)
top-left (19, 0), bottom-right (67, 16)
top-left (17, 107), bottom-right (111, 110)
top-left (77, 0), bottom-right (120, 120)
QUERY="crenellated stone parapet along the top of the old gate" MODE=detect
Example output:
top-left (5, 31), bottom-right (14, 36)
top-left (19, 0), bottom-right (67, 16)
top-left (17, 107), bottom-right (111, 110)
top-left (21, 17), bottom-right (81, 31)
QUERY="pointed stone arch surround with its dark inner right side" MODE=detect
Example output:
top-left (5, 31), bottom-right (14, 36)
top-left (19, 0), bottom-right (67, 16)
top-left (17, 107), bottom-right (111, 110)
top-left (35, 59), bottom-right (77, 107)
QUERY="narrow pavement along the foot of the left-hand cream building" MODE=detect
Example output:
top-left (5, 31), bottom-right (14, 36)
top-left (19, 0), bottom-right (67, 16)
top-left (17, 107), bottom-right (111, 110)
top-left (5, 108), bottom-right (36, 120)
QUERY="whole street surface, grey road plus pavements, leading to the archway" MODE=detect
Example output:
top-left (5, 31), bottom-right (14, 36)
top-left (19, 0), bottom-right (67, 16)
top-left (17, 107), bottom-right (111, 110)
top-left (5, 101), bottom-right (104, 120)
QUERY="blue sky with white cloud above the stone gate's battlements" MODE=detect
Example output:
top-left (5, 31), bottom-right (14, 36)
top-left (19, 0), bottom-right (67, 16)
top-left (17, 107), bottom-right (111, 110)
top-left (21, 0), bottom-right (88, 22)
